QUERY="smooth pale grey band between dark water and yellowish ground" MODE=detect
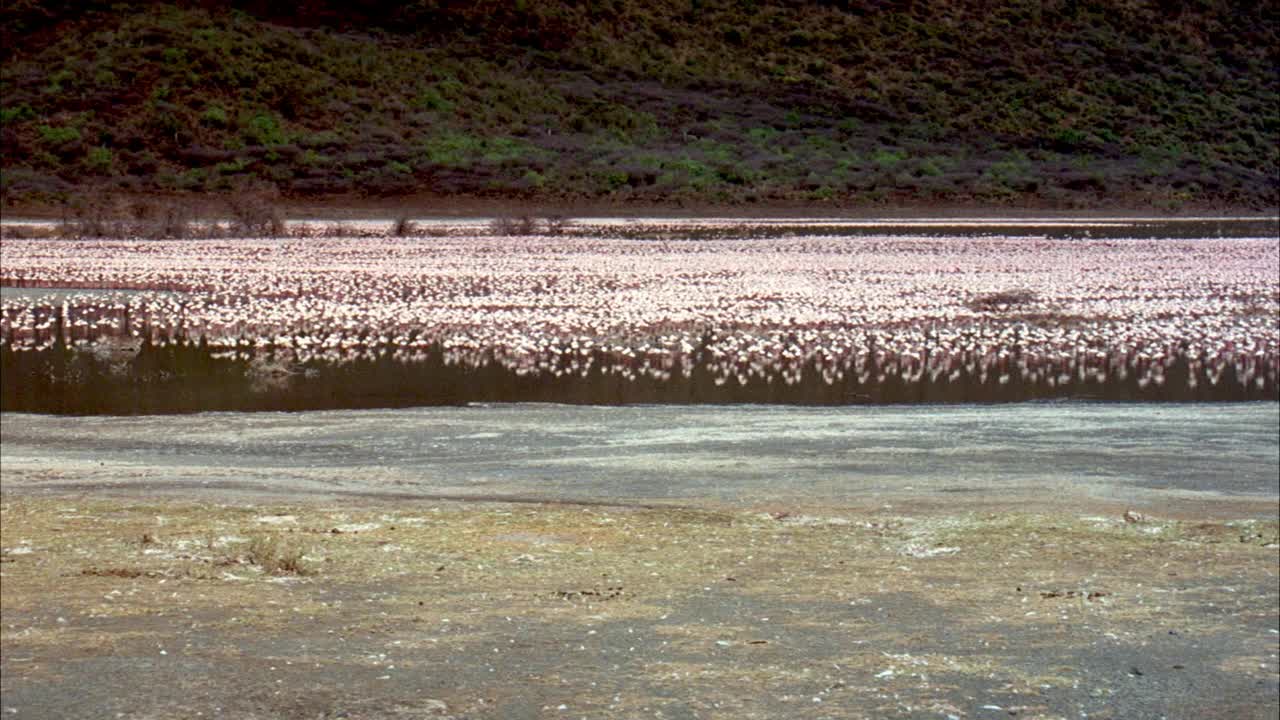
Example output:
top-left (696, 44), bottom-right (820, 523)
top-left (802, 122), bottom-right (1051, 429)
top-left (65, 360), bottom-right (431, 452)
top-left (0, 402), bottom-right (1280, 503)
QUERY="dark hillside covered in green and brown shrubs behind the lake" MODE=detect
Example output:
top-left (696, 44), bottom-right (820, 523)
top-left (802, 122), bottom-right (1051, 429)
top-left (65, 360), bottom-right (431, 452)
top-left (0, 0), bottom-right (1280, 209)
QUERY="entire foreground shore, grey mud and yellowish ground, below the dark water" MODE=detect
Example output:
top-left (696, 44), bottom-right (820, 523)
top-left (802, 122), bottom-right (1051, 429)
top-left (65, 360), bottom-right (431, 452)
top-left (0, 404), bottom-right (1280, 720)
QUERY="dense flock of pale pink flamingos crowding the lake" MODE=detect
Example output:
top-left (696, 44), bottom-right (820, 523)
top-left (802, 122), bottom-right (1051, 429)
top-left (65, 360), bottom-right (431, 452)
top-left (0, 219), bottom-right (1280, 395)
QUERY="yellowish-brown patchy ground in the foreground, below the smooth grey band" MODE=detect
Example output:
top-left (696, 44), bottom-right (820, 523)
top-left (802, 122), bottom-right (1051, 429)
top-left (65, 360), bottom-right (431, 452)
top-left (0, 492), bottom-right (1280, 719)
